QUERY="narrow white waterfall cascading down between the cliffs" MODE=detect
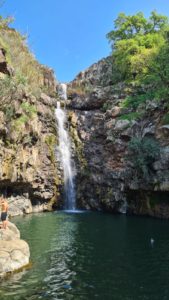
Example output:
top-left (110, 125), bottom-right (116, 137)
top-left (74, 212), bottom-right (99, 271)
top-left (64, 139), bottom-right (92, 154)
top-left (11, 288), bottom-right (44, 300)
top-left (55, 102), bottom-right (76, 210)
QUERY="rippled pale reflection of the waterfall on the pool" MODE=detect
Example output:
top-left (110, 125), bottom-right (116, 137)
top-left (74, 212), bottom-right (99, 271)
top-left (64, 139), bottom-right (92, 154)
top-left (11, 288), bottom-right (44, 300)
top-left (44, 216), bottom-right (78, 296)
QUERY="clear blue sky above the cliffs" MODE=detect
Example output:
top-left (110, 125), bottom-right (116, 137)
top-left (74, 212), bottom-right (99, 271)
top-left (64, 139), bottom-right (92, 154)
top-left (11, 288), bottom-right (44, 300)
top-left (0, 0), bottom-right (169, 82)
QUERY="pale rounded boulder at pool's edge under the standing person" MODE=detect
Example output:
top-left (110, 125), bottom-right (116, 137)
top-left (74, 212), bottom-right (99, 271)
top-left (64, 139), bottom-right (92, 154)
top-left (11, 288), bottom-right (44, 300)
top-left (0, 222), bottom-right (30, 277)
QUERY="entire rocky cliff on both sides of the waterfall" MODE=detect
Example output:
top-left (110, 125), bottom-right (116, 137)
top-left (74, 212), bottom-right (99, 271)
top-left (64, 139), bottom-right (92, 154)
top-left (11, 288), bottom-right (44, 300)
top-left (0, 22), bottom-right (169, 217)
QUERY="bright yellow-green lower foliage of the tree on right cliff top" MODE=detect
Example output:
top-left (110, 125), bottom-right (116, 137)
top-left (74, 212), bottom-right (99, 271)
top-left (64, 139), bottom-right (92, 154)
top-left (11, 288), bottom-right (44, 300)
top-left (113, 33), bottom-right (165, 80)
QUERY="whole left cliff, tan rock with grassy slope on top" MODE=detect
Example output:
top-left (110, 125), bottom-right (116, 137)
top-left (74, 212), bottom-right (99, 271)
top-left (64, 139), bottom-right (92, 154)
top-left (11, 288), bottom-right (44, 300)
top-left (0, 27), bottom-right (61, 215)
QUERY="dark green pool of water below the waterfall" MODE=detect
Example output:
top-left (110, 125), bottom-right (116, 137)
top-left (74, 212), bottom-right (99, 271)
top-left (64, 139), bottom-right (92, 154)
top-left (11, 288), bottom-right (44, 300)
top-left (0, 213), bottom-right (169, 300)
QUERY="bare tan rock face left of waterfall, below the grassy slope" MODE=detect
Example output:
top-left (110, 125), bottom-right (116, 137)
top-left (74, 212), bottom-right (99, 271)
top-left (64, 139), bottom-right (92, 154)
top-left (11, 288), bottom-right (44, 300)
top-left (0, 88), bottom-right (63, 214)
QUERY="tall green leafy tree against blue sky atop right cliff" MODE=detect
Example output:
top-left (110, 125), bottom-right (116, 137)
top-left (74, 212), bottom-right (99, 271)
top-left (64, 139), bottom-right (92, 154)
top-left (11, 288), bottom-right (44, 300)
top-left (107, 11), bottom-right (169, 82)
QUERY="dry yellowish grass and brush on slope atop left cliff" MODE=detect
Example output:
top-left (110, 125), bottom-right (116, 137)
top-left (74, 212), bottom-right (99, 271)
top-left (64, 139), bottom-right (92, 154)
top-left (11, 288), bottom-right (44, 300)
top-left (0, 16), bottom-right (55, 102)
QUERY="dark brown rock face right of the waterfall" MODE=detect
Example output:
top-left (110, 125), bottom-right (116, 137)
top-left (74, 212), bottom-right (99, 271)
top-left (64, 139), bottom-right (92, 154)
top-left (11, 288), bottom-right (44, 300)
top-left (67, 58), bottom-right (169, 218)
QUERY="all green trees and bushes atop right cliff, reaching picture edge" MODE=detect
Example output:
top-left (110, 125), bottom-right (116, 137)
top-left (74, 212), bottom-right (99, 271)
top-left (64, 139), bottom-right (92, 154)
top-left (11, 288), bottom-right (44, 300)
top-left (107, 11), bottom-right (169, 109)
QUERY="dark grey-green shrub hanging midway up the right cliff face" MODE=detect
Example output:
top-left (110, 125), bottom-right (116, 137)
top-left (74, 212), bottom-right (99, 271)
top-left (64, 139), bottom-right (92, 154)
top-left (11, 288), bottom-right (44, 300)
top-left (127, 137), bottom-right (160, 179)
